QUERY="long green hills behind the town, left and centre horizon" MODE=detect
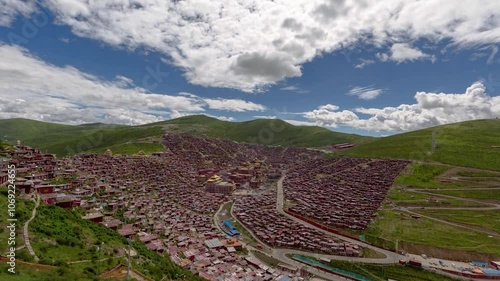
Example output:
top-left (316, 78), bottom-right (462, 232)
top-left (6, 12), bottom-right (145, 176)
top-left (0, 115), bottom-right (372, 156)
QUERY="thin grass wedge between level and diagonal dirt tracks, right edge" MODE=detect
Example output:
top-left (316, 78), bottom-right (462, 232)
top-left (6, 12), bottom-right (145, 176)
top-left (418, 210), bottom-right (500, 234)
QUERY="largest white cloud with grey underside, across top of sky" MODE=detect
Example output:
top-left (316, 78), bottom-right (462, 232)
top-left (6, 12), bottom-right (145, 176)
top-left (0, 0), bottom-right (500, 92)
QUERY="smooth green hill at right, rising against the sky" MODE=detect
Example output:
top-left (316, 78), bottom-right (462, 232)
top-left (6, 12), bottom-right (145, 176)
top-left (343, 119), bottom-right (500, 170)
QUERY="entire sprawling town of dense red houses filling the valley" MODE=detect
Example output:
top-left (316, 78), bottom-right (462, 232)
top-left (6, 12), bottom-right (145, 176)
top-left (0, 134), bottom-right (407, 280)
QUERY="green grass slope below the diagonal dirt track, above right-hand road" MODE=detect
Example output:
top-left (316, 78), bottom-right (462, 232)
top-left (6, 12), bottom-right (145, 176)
top-left (366, 211), bottom-right (500, 255)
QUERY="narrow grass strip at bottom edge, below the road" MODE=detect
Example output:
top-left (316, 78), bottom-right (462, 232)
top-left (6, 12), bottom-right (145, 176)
top-left (330, 260), bottom-right (457, 281)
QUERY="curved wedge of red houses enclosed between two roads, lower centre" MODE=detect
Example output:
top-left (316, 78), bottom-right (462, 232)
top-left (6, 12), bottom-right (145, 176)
top-left (233, 193), bottom-right (361, 256)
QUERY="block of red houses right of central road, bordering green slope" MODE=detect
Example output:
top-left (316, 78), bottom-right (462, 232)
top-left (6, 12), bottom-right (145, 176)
top-left (283, 158), bottom-right (408, 230)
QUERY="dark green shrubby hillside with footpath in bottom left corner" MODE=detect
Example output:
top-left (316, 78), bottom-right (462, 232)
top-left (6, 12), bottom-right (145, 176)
top-left (0, 187), bottom-right (202, 280)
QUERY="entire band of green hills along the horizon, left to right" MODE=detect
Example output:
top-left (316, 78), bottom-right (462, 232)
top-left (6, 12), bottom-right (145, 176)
top-left (0, 115), bottom-right (500, 170)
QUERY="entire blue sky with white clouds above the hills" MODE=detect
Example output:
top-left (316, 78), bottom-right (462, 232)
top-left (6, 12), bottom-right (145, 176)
top-left (0, 0), bottom-right (500, 136)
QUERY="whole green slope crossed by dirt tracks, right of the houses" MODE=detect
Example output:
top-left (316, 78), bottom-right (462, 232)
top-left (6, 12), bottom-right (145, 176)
top-left (366, 160), bottom-right (500, 259)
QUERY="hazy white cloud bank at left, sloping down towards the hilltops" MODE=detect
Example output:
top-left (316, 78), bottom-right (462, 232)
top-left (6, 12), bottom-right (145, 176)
top-left (0, 45), bottom-right (265, 125)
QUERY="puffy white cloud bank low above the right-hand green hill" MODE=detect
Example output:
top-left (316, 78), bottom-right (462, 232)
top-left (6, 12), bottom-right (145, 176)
top-left (303, 82), bottom-right (500, 132)
